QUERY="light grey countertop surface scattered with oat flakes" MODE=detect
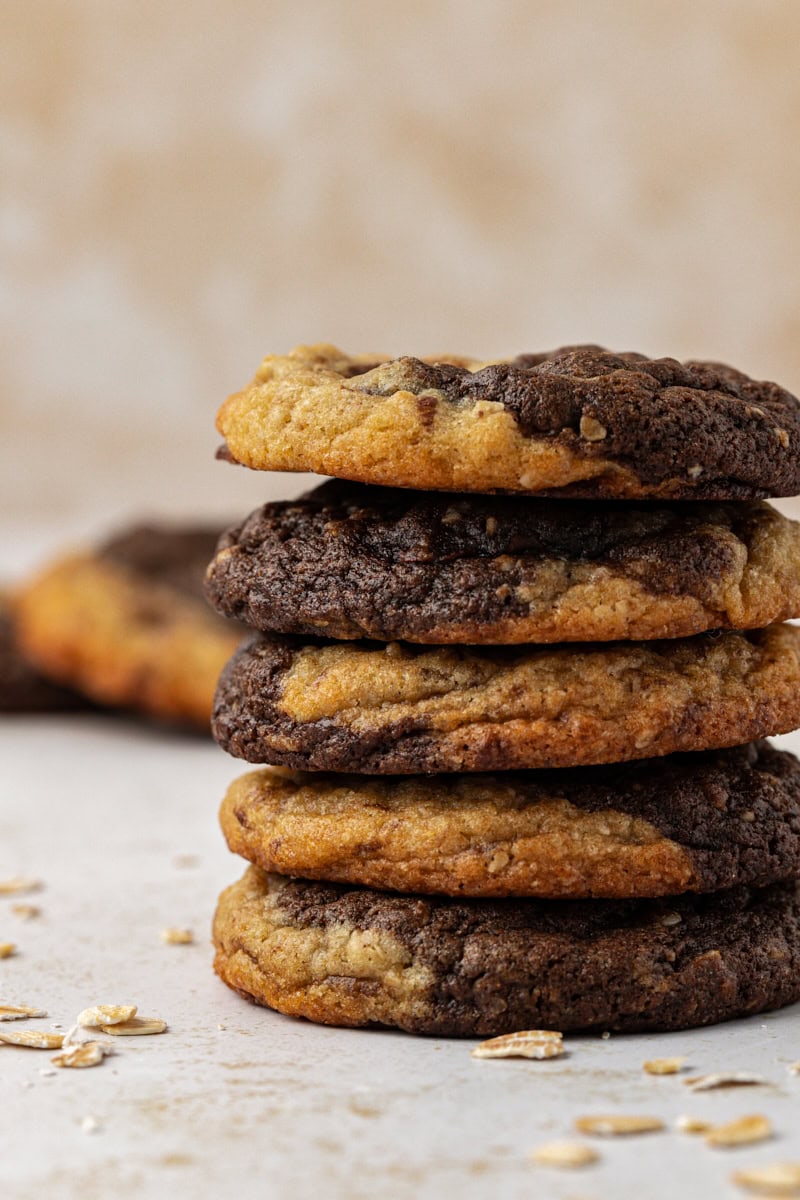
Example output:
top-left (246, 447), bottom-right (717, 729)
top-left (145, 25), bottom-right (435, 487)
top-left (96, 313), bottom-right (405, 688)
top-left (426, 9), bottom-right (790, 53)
top-left (0, 716), bottom-right (800, 1200)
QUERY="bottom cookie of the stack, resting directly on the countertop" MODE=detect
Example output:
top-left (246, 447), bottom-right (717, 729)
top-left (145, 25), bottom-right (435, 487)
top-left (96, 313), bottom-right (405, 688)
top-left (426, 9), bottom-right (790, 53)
top-left (213, 866), bottom-right (800, 1037)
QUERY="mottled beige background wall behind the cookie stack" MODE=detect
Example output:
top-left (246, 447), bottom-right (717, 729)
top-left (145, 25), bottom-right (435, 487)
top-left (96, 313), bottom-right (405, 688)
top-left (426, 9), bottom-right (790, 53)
top-left (0, 0), bottom-right (800, 537)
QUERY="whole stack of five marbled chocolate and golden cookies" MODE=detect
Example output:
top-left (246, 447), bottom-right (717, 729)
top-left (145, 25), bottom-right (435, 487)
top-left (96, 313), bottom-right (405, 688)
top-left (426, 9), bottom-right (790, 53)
top-left (206, 347), bottom-right (800, 1037)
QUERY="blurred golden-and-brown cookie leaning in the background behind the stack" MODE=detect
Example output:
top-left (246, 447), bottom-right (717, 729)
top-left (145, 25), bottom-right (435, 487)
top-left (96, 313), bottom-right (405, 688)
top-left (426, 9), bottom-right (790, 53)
top-left (18, 526), bottom-right (241, 728)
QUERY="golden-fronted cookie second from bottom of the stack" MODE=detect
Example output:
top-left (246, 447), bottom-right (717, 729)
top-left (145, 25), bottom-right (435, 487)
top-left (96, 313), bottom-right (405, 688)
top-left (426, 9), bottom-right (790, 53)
top-left (219, 743), bottom-right (800, 899)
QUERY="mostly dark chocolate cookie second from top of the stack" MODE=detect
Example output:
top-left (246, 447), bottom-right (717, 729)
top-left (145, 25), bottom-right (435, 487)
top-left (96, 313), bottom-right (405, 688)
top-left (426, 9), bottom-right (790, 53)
top-left (206, 481), bottom-right (800, 644)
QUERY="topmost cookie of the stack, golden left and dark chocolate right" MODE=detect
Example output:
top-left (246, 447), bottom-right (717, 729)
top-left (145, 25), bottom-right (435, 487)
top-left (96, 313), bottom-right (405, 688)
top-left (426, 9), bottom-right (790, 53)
top-left (217, 346), bottom-right (800, 500)
